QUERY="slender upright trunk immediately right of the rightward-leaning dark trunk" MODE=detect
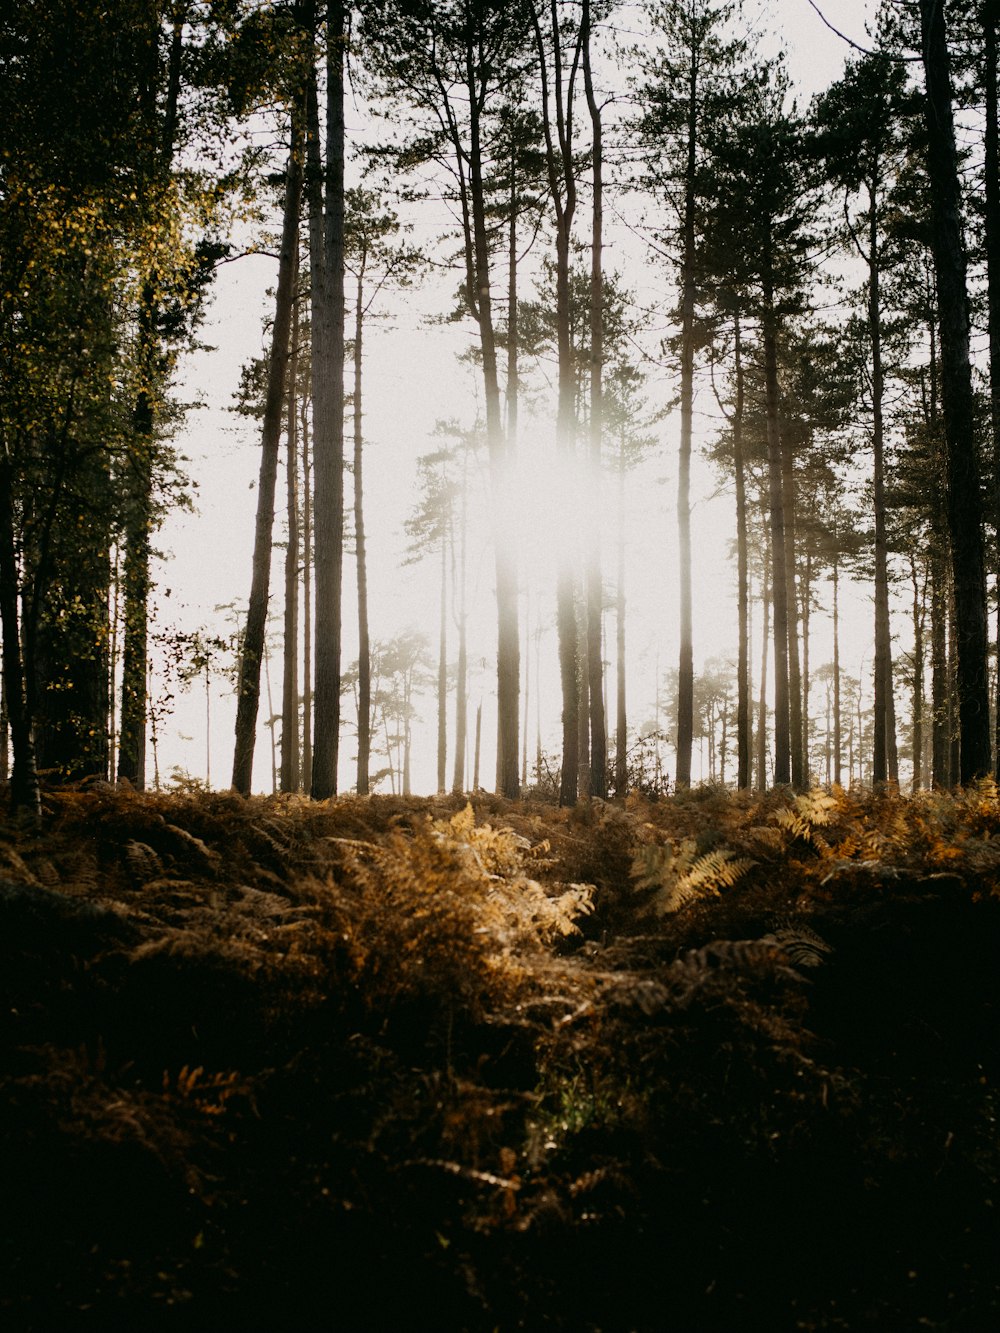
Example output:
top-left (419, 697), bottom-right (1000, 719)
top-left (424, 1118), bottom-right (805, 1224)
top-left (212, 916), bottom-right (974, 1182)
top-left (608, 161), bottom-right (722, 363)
top-left (281, 271), bottom-right (300, 792)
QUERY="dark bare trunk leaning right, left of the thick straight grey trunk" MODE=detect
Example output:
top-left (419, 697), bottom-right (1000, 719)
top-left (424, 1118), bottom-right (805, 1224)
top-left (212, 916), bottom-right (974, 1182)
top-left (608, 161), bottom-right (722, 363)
top-left (232, 108), bottom-right (303, 796)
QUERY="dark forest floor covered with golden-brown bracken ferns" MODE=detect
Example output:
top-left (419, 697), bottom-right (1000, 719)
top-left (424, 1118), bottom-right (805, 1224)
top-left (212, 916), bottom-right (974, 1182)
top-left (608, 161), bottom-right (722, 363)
top-left (0, 786), bottom-right (1000, 1333)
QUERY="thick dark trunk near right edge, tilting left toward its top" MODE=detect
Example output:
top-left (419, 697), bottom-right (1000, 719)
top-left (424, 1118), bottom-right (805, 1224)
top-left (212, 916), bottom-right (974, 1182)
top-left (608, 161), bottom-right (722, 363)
top-left (920, 0), bottom-right (991, 784)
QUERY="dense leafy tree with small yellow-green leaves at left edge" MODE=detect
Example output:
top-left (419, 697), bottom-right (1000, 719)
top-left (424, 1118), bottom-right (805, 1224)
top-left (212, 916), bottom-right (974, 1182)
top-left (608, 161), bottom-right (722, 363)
top-left (0, 0), bottom-right (229, 806)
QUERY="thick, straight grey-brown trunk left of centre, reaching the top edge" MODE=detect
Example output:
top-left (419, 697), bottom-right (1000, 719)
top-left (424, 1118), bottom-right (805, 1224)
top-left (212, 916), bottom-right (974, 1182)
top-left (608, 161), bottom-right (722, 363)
top-left (309, 0), bottom-right (345, 800)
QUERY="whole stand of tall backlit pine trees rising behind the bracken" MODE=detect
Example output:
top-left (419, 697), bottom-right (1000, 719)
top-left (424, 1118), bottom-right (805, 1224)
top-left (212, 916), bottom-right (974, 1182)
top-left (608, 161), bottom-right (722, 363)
top-left (0, 0), bottom-right (1000, 809)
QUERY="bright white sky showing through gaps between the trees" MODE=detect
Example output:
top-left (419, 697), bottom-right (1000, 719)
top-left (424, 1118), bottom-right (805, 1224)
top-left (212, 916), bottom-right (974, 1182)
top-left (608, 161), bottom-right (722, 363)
top-left (160, 0), bottom-right (873, 792)
